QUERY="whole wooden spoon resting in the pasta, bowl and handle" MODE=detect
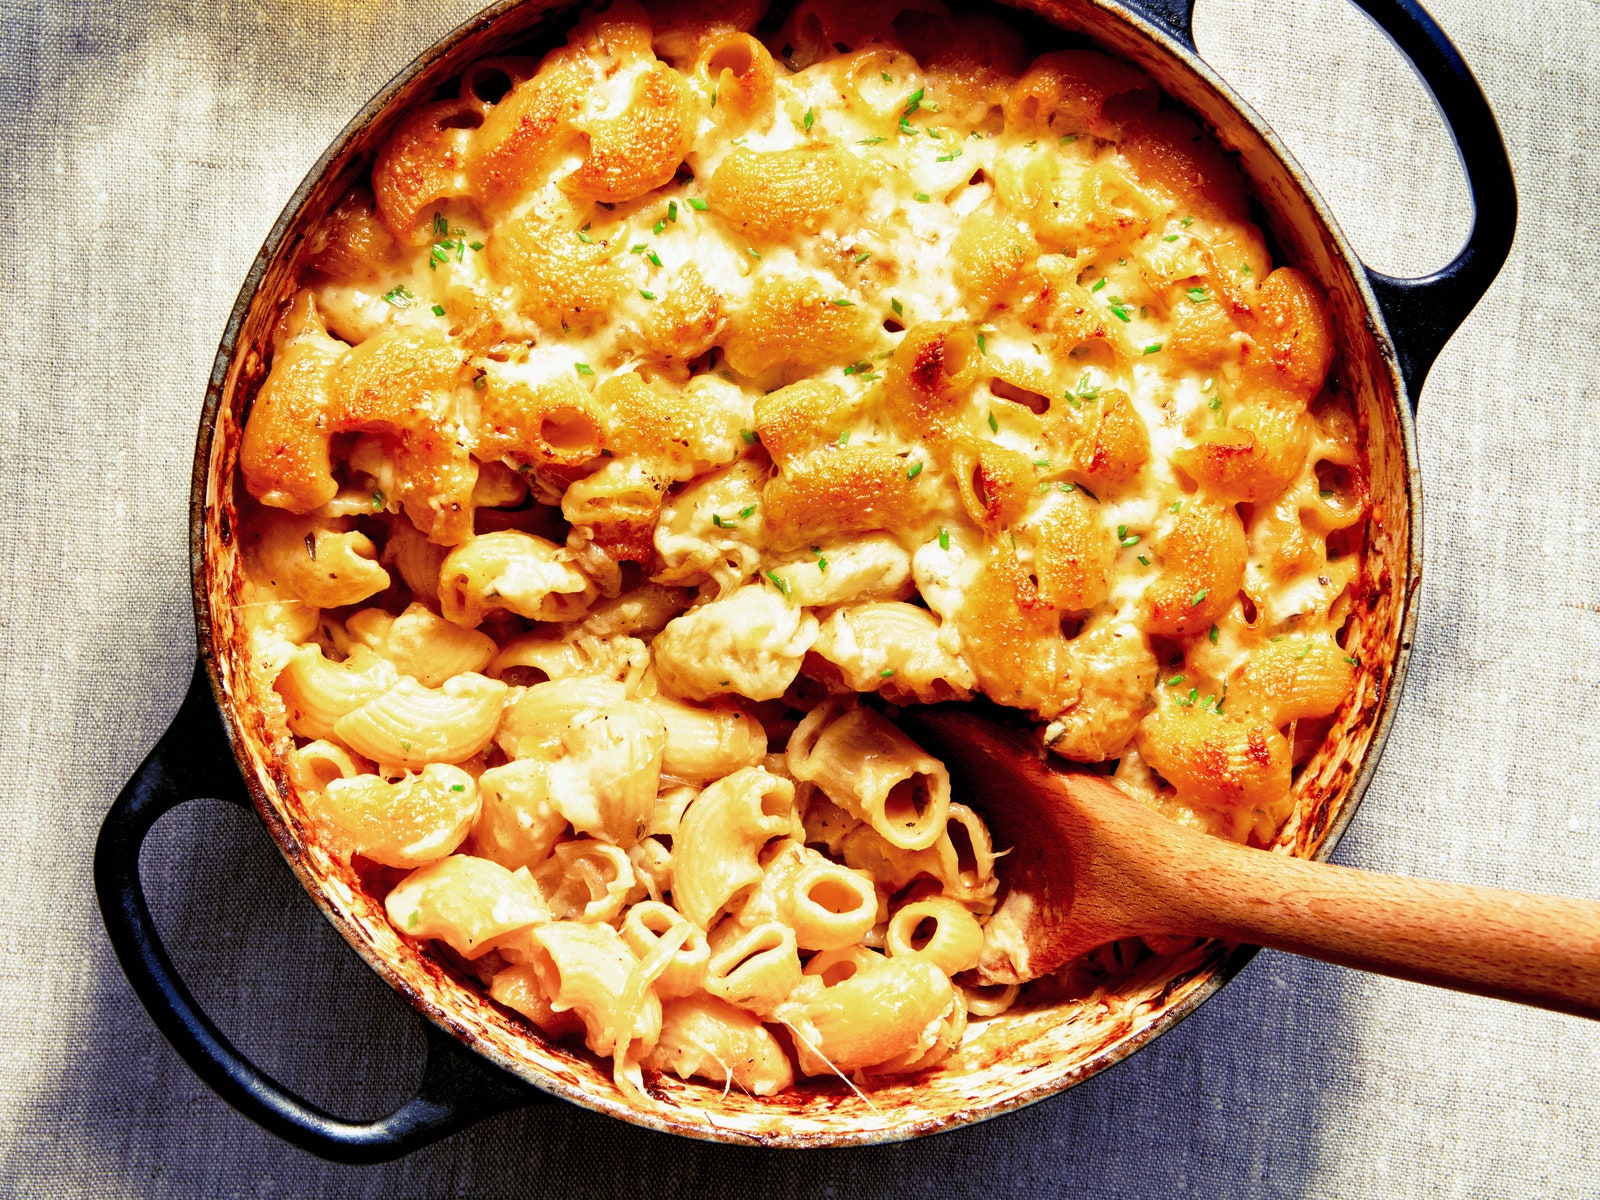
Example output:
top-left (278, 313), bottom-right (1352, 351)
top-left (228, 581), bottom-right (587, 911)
top-left (899, 706), bottom-right (1600, 1018)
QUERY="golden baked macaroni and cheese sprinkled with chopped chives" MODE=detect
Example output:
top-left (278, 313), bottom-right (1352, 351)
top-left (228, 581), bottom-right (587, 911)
top-left (238, 0), bottom-right (1365, 1094)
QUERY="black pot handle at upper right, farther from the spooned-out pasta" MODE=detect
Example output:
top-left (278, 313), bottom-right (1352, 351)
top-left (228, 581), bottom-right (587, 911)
top-left (1122, 0), bottom-right (1517, 410)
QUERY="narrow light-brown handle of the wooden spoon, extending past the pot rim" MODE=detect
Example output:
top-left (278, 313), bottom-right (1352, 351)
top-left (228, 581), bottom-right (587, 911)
top-left (1165, 843), bottom-right (1600, 1018)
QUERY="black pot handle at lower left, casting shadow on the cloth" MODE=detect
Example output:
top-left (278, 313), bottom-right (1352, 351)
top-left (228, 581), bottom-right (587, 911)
top-left (94, 662), bottom-right (549, 1163)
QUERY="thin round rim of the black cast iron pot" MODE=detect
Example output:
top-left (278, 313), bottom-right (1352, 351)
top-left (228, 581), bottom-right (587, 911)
top-left (189, 0), bottom-right (1422, 1149)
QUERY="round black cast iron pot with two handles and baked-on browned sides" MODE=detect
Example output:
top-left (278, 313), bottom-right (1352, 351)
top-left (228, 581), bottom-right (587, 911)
top-left (94, 0), bottom-right (1517, 1162)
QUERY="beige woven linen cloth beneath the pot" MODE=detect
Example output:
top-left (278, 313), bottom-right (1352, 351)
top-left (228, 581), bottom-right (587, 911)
top-left (0, 0), bottom-right (1600, 1198)
